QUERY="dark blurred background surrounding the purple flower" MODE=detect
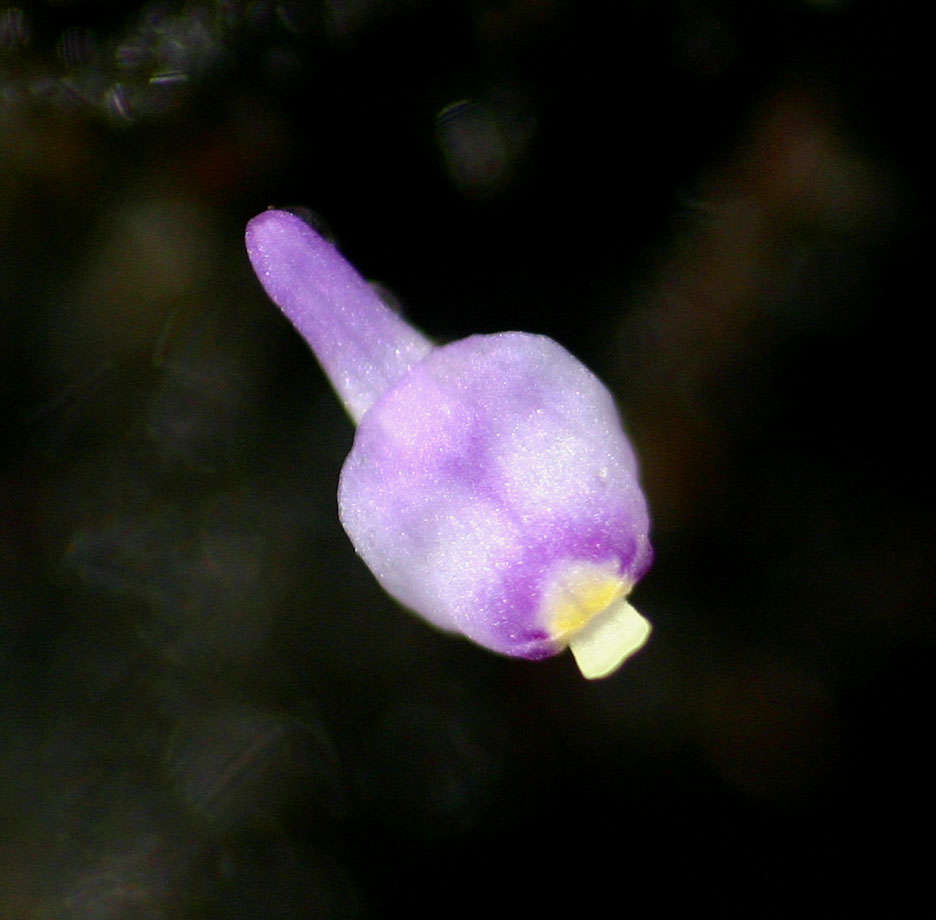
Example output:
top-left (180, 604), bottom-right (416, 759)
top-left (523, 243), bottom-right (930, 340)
top-left (0, 0), bottom-right (936, 920)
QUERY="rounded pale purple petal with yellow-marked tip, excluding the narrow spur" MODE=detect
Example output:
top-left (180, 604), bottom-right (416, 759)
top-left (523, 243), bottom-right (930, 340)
top-left (339, 332), bottom-right (651, 658)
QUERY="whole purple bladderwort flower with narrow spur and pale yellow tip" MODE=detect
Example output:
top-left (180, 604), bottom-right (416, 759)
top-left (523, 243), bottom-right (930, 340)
top-left (246, 210), bottom-right (652, 678)
